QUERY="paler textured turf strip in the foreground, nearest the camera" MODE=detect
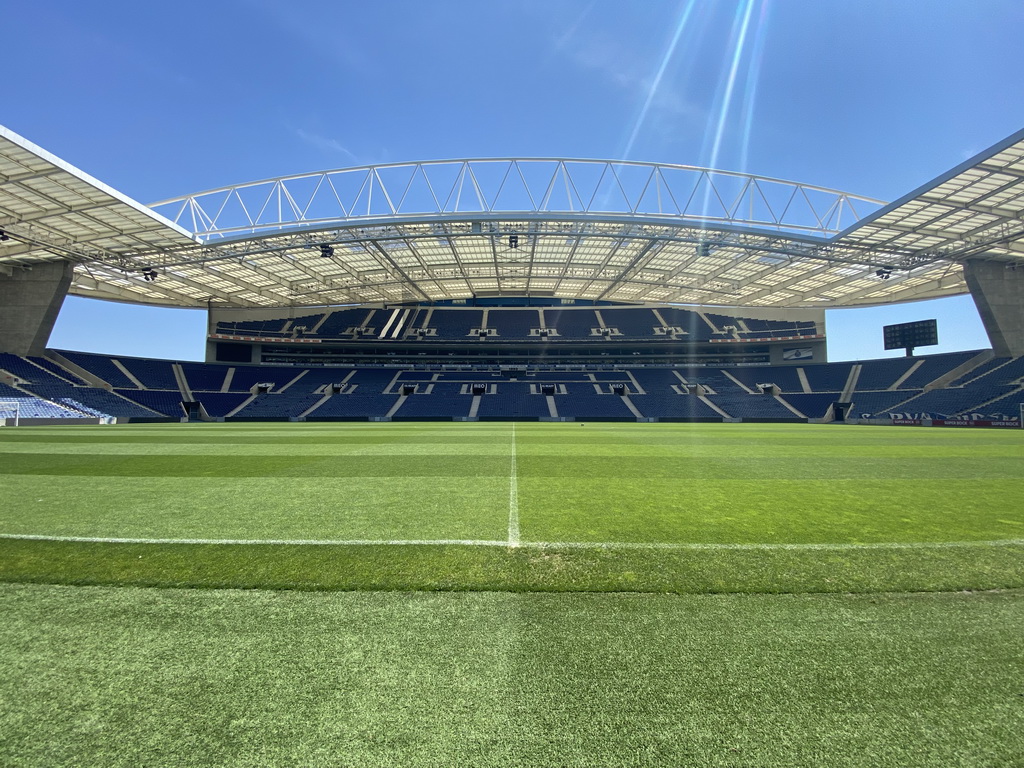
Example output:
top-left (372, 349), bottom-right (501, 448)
top-left (0, 585), bottom-right (1024, 768)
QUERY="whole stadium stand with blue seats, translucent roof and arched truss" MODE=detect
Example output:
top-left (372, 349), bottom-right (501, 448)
top-left (0, 124), bottom-right (1024, 423)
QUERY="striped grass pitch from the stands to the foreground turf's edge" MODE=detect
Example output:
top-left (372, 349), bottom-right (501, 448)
top-left (0, 423), bottom-right (1024, 593)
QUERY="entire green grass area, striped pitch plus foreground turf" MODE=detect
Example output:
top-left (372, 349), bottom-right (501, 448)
top-left (0, 423), bottom-right (1024, 767)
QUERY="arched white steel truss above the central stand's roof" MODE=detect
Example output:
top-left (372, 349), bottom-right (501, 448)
top-left (153, 158), bottom-right (883, 242)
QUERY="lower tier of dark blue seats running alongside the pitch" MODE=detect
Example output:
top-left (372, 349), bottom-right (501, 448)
top-left (0, 351), bottom-right (1024, 419)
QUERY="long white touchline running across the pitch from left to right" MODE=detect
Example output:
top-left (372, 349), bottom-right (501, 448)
top-left (0, 534), bottom-right (1024, 551)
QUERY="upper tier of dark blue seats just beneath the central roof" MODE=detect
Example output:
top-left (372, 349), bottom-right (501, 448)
top-left (215, 307), bottom-right (817, 341)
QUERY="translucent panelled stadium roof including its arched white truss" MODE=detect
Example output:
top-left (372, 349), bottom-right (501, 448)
top-left (0, 123), bottom-right (1024, 307)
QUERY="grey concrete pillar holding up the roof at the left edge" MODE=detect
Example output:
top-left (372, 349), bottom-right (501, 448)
top-left (0, 261), bottom-right (75, 354)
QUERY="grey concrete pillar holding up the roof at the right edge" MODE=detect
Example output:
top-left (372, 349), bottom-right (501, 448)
top-left (964, 260), bottom-right (1024, 357)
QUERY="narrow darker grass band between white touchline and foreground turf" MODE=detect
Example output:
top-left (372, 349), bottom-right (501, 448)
top-left (0, 539), bottom-right (1024, 594)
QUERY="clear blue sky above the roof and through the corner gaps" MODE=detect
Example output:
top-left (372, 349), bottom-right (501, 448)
top-left (0, 0), bottom-right (1024, 359)
